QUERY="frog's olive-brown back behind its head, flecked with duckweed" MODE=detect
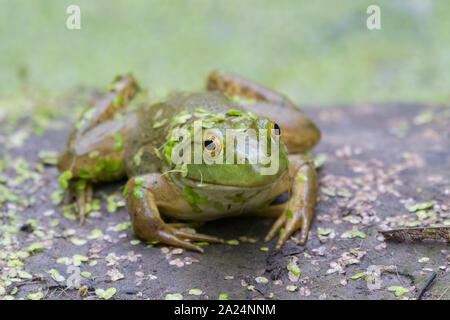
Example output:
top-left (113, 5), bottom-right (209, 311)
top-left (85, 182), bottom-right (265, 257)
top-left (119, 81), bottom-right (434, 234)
top-left (125, 92), bottom-right (240, 177)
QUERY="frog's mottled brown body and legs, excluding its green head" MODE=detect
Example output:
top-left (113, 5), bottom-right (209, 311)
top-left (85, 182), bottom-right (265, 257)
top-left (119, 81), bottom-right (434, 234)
top-left (58, 73), bottom-right (320, 252)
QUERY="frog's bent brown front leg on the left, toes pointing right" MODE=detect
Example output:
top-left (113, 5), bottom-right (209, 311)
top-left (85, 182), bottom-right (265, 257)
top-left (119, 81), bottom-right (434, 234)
top-left (126, 173), bottom-right (224, 253)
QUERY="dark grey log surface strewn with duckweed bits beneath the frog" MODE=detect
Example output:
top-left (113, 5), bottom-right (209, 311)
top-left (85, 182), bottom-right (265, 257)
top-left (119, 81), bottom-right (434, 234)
top-left (0, 104), bottom-right (450, 299)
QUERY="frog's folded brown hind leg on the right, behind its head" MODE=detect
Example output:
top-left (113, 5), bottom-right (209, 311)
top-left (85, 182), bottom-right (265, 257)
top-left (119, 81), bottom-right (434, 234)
top-left (207, 72), bottom-right (321, 153)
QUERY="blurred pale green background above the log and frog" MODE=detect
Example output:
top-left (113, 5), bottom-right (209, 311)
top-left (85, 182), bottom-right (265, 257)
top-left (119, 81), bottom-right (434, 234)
top-left (0, 0), bottom-right (450, 105)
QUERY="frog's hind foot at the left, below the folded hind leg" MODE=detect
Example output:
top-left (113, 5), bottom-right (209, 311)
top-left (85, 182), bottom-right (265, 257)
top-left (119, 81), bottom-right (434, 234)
top-left (64, 179), bottom-right (94, 225)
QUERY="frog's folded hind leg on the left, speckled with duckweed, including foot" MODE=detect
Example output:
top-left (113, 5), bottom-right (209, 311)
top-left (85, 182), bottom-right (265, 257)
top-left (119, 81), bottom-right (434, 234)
top-left (58, 75), bottom-right (138, 223)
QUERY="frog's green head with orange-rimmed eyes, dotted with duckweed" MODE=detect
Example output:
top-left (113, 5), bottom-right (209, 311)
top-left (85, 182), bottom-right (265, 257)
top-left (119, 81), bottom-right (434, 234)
top-left (163, 108), bottom-right (289, 188)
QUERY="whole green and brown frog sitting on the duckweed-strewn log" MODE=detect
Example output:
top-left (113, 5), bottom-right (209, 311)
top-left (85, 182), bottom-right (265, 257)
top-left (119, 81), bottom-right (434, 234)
top-left (57, 71), bottom-right (321, 253)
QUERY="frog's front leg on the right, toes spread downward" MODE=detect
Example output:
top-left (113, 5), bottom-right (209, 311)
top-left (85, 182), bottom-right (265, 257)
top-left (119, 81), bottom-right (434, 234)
top-left (264, 155), bottom-right (318, 249)
